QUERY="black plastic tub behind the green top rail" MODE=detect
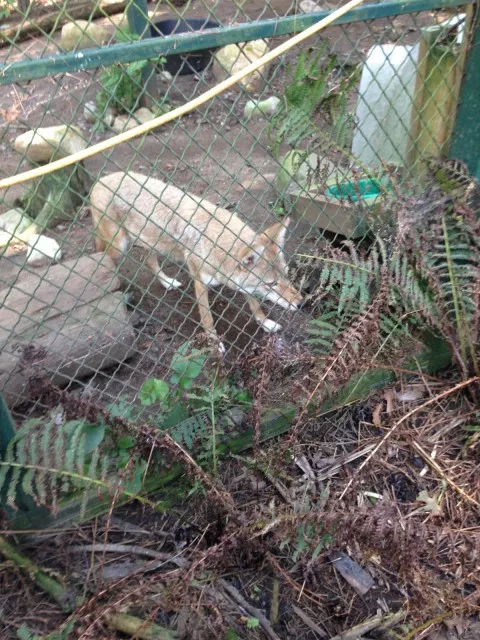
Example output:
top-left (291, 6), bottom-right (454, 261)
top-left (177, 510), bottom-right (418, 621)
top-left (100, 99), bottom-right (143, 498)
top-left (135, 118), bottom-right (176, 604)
top-left (152, 18), bottom-right (220, 76)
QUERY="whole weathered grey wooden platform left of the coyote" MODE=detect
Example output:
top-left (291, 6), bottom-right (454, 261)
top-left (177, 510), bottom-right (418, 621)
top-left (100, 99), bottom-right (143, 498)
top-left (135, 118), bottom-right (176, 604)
top-left (0, 253), bottom-right (135, 407)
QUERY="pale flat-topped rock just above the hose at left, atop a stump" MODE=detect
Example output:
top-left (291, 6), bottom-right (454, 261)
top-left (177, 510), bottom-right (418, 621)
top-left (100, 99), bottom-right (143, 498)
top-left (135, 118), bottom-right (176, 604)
top-left (15, 124), bottom-right (87, 163)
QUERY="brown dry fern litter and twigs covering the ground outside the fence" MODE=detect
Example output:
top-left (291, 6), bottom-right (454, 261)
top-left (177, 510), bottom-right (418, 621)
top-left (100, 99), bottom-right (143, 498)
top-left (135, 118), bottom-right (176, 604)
top-left (0, 362), bottom-right (480, 640)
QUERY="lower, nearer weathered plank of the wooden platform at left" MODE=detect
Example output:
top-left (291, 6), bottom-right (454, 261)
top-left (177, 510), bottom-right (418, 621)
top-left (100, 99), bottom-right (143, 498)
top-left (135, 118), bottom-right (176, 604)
top-left (0, 292), bottom-right (135, 407)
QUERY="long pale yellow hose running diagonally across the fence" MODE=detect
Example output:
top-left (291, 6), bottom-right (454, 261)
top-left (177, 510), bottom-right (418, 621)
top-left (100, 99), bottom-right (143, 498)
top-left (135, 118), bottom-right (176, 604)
top-left (0, 0), bottom-right (363, 189)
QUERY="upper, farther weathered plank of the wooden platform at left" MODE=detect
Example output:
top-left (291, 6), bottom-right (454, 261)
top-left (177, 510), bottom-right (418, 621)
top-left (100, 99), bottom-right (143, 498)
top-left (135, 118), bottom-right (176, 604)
top-left (0, 253), bottom-right (120, 348)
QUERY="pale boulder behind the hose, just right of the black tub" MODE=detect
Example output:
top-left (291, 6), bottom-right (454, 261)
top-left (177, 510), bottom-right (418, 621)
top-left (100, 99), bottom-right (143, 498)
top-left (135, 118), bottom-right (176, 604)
top-left (213, 40), bottom-right (270, 93)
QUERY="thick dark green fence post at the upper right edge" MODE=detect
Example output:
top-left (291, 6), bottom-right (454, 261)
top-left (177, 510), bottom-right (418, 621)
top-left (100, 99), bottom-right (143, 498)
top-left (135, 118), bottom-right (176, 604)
top-left (450, 7), bottom-right (480, 181)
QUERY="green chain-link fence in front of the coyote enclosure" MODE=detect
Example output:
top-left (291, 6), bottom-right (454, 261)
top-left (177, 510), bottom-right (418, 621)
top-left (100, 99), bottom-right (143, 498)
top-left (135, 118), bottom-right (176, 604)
top-left (0, 0), bottom-right (478, 416)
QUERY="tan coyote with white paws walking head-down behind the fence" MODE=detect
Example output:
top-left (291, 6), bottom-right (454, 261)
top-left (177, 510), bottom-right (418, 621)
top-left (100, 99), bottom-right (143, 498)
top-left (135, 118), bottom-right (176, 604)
top-left (91, 172), bottom-right (302, 348)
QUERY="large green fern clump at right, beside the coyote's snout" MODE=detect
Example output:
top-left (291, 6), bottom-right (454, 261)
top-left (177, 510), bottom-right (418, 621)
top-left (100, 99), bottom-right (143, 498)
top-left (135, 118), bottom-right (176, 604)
top-left (310, 161), bottom-right (480, 375)
